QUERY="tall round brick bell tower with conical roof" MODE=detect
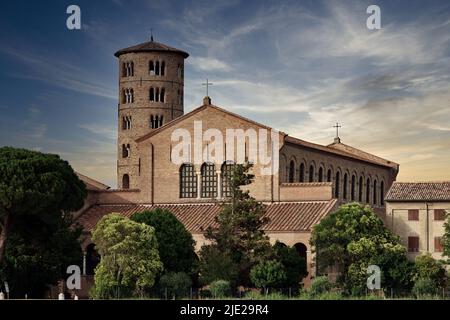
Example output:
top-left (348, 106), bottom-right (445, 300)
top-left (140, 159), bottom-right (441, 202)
top-left (114, 36), bottom-right (189, 189)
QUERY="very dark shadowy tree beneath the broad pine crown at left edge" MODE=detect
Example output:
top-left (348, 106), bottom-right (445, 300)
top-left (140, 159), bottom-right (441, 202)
top-left (0, 215), bottom-right (82, 298)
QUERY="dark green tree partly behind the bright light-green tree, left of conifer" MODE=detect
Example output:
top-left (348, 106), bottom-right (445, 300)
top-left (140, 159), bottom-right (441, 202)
top-left (131, 208), bottom-right (198, 275)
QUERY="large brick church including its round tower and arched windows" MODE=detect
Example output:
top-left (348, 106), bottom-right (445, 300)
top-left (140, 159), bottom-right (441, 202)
top-left (76, 39), bottom-right (399, 284)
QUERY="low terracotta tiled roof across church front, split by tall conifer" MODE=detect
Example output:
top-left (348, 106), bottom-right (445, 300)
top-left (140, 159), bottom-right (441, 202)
top-left (77, 199), bottom-right (337, 233)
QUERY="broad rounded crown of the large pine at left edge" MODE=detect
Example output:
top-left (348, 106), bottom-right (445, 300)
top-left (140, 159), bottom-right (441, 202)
top-left (0, 147), bottom-right (86, 263)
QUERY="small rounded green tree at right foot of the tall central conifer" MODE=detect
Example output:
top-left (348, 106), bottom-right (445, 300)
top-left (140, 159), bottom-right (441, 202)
top-left (250, 260), bottom-right (286, 292)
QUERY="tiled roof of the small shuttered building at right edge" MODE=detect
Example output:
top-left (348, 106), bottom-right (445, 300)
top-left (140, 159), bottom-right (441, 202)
top-left (386, 181), bottom-right (450, 201)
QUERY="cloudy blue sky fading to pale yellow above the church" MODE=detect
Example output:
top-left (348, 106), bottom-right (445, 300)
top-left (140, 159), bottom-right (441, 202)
top-left (0, 0), bottom-right (450, 187)
